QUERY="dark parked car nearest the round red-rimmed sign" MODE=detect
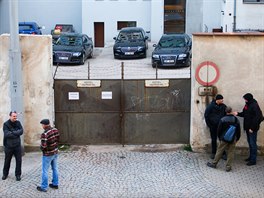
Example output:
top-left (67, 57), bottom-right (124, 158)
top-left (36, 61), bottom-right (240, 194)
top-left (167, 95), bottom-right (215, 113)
top-left (152, 33), bottom-right (192, 68)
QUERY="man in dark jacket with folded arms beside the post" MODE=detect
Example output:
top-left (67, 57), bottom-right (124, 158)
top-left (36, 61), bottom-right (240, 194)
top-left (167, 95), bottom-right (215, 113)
top-left (2, 111), bottom-right (23, 181)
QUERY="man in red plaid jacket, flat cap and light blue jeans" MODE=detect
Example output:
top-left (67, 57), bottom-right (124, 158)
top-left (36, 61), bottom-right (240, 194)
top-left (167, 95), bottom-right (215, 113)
top-left (37, 119), bottom-right (59, 192)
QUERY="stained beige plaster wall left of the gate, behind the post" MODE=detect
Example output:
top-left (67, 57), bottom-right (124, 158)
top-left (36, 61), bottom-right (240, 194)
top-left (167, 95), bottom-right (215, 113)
top-left (0, 34), bottom-right (54, 146)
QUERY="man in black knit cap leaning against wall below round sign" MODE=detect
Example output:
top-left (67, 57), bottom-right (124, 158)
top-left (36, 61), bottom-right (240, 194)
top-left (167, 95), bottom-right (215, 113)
top-left (204, 94), bottom-right (226, 159)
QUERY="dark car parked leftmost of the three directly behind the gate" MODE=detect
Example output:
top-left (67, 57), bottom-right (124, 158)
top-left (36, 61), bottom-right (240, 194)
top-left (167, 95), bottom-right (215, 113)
top-left (53, 33), bottom-right (93, 65)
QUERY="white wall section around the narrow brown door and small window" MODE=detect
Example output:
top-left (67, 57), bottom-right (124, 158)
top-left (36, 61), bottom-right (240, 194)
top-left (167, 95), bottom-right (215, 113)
top-left (82, 0), bottom-right (151, 44)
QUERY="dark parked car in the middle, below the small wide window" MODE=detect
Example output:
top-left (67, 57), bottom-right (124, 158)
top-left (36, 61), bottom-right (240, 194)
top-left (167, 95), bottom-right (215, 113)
top-left (113, 27), bottom-right (148, 58)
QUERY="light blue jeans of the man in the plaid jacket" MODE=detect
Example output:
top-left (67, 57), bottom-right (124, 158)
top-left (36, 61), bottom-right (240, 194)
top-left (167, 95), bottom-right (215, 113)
top-left (41, 154), bottom-right (59, 190)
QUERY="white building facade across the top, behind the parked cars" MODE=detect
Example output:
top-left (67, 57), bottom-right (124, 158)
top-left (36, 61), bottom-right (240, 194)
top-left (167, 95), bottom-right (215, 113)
top-left (0, 0), bottom-right (264, 44)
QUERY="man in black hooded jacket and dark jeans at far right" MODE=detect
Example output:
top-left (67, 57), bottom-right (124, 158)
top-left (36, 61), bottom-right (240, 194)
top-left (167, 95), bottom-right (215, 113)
top-left (234, 93), bottom-right (263, 166)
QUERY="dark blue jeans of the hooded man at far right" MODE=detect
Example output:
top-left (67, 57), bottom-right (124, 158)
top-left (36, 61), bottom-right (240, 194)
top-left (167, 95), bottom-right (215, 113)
top-left (246, 131), bottom-right (257, 163)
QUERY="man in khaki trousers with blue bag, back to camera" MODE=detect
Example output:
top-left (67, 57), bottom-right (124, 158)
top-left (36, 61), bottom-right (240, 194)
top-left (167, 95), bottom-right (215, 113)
top-left (207, 107), bottom-right (241, 172)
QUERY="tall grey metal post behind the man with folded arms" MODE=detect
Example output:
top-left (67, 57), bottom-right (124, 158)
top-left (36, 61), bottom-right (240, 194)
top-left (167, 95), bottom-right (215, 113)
top-left (9, 0), bottom-right (24, 154)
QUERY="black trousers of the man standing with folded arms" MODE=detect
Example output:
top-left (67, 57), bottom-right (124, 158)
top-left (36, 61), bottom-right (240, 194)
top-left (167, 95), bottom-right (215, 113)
top-left (3, 146), bottom-right (22, 176)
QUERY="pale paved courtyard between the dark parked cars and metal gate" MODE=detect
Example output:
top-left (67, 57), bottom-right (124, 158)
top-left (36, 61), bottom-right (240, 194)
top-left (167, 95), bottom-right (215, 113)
top-left (53, 43), bottom-right (191, 79)
